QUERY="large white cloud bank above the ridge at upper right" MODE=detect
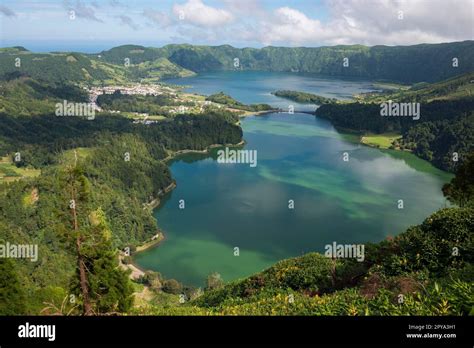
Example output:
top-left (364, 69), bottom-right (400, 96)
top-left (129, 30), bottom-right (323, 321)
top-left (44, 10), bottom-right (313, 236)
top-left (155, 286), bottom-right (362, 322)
top-left (256, 0), bottom-right (474, 45)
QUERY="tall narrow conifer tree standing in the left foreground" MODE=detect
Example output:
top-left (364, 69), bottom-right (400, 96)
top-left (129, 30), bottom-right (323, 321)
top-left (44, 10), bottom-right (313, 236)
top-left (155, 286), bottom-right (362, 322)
top-left (66, 163), bottom-right (133, 315)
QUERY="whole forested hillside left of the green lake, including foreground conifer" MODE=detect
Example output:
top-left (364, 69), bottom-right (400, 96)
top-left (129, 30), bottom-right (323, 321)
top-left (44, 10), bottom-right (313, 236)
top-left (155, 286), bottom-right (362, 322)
top-left (0, 111), bottom-right (242, 314)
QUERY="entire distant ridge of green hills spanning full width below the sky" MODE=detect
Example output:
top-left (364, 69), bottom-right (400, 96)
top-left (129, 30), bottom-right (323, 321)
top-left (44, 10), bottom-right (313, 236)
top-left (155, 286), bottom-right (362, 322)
top-left (0, 41), bottom-right (474, 85)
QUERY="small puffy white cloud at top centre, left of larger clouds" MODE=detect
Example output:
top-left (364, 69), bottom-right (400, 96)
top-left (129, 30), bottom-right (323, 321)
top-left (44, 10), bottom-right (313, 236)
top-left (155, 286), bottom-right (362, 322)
top-left (173, 0), bottom-right (234, 28)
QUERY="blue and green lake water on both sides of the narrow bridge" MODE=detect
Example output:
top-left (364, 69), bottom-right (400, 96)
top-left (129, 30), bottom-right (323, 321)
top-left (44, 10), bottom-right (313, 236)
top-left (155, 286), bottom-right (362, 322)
top-left (135, 72), bottom-right (450, 286)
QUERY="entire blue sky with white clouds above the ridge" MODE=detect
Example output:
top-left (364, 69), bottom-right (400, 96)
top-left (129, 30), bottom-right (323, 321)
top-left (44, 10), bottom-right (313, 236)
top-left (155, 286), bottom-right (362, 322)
top-left (0, 0), bottom-right (474, 52)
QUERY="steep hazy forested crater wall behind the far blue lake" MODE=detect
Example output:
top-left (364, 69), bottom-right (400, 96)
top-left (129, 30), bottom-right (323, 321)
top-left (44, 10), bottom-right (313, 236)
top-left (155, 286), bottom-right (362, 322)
top-left (100, 41), bottom-right (474, 83)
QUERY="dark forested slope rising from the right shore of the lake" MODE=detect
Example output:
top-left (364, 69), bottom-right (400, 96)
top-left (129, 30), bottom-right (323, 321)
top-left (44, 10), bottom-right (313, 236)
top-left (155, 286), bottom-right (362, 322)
top-left (316, 73), bottom-right (474, 172)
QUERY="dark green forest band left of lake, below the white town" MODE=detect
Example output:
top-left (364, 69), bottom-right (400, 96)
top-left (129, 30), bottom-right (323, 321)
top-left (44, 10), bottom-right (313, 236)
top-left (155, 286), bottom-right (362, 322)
top-left (0, 111), bottom-right (242, 168)
